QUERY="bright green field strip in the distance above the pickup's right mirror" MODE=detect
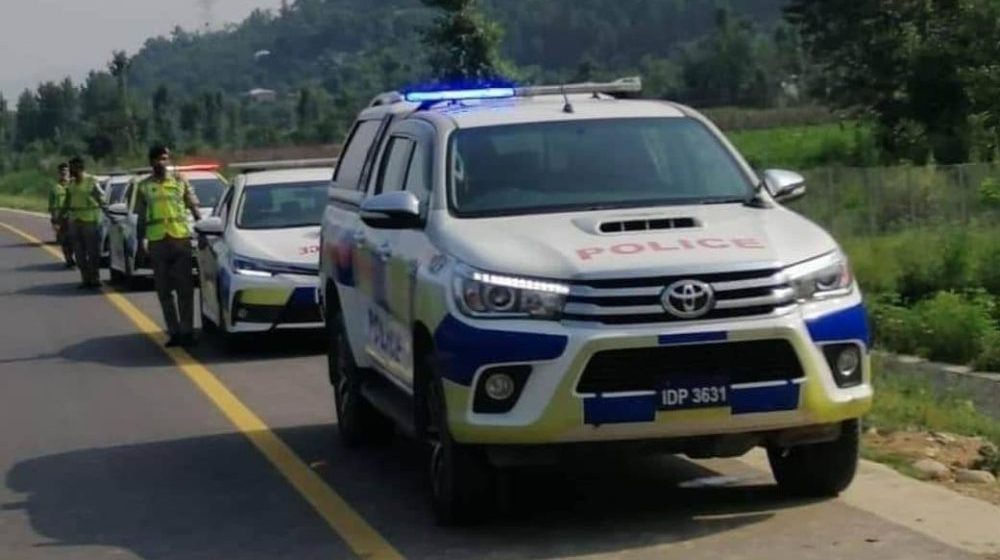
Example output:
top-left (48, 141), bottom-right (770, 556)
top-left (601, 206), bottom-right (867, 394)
top-left (726, 122), bottom-right (870, 170)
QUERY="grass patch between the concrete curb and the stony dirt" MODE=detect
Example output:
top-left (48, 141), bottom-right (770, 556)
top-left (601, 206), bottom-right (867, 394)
top-left (865, 363), bottom-right (1000, 448)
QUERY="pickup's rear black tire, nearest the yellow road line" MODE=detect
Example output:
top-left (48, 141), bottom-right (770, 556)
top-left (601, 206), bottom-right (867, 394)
top-left (327, 310), bottom-right (395, 448)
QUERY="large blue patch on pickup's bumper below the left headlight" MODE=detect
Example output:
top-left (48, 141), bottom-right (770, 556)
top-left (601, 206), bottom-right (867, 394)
top-left (434, 315), bottom-right (569, 386)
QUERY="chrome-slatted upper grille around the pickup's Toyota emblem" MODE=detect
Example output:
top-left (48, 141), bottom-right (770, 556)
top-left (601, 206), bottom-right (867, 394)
top-left (563, 268), bottom-right (795, 325)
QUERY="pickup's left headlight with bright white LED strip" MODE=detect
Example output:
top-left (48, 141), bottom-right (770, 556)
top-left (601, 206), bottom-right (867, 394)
top-left (454, 267), bottom-right (569, 319)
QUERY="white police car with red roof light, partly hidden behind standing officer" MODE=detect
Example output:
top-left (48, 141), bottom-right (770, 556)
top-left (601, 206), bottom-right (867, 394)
top-left (107, 164), bottom-right (227, 286)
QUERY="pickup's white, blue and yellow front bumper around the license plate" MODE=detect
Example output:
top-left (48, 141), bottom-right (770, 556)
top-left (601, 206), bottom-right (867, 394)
top-left (435, 294), bottom-right (872, 445)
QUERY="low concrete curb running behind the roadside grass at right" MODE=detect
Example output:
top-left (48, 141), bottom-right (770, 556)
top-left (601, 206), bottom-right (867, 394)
top-left (872, 351), bottom-right (1000, 420)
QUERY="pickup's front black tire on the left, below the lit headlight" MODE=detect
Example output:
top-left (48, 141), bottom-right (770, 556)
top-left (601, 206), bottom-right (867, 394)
top-left (423, 359), bottom-right (498, 526)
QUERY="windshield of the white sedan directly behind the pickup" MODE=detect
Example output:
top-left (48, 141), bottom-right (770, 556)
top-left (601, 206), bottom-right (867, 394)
top-left (236, 180), bottom-right (330, 229)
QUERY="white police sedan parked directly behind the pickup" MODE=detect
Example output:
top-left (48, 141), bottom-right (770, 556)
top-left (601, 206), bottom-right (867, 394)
top-left (195, 159), bottom-right (336, 335)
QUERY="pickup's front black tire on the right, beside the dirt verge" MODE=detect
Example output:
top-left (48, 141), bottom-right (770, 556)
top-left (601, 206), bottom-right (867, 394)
top-left (767, 420), bottom-right (861, 498)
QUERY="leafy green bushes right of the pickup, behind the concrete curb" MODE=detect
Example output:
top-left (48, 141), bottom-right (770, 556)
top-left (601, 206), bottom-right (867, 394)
top-left (844, 225), bottom-right (1000, 371)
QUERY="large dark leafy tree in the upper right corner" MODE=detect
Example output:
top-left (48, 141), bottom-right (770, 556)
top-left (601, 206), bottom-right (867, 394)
top-left (786, 0), bottom-right (972, 163)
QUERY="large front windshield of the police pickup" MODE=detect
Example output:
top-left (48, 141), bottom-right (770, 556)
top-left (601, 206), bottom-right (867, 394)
top-left (450, 118), bottom-right (753, 217)
